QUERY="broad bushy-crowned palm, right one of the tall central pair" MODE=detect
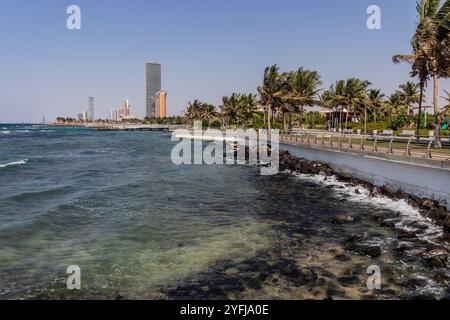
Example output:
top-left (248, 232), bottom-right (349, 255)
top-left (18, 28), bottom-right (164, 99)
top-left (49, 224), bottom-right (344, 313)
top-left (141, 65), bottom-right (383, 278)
top-left (284, 67), bottom-right (322, 128)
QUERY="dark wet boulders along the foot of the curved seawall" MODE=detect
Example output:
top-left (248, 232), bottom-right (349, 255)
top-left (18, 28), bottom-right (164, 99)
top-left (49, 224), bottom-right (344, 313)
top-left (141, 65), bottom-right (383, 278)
top-left (280, 151), bottom-right (450, 272)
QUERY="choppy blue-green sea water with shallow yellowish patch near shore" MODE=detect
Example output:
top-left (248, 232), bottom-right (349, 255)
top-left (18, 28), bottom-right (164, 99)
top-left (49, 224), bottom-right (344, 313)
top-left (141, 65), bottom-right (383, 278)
top-left (0, 125), bottom-right (448, 299)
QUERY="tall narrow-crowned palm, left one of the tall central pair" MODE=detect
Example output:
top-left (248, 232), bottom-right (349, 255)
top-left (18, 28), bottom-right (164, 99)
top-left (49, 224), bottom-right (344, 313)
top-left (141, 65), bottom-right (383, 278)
top-left (258, 64), bottom-right (285, 136)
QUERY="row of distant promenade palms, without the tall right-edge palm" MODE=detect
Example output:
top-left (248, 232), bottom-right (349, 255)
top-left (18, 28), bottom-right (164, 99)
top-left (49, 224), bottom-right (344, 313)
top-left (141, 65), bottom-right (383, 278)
top-left (186, 69), bottom-right (428, 131)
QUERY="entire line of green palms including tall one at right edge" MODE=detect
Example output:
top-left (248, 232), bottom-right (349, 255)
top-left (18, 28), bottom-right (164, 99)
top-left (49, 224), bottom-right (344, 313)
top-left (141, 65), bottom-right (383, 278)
top-left (186, 0), bottom-right (450, 146)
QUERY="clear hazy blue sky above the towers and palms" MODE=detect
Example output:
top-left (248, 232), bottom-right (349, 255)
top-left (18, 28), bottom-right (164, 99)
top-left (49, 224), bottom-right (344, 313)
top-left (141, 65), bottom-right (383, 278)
top-left (0, 0), bottom-right (450, 123)
